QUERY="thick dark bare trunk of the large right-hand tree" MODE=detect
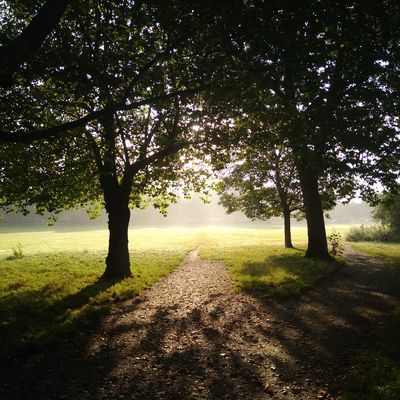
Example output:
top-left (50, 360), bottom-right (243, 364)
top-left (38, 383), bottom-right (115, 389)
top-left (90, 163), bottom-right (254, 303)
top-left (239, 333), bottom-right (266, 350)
top-left (297, 165), bottom-right (330, 259)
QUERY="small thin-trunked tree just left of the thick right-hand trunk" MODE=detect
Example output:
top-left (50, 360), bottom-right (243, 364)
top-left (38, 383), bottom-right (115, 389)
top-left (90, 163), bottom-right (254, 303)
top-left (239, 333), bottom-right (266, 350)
top-left (218, 146), bottom-right (304, 248)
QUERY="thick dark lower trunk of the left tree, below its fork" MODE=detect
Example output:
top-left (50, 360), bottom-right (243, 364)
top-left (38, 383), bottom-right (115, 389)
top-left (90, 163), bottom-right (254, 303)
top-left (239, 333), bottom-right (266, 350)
top-left (103, 201), bottom-right (131, 279)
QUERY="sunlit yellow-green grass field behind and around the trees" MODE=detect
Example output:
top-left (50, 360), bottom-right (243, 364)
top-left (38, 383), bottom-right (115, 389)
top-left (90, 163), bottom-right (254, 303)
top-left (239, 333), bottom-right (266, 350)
top-left (0, 228), bottom-right (344, 355)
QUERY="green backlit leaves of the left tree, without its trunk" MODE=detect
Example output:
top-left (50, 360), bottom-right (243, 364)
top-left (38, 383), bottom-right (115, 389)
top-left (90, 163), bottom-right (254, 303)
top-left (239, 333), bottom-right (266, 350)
top-left (1, 1), bottom-right (212, 211)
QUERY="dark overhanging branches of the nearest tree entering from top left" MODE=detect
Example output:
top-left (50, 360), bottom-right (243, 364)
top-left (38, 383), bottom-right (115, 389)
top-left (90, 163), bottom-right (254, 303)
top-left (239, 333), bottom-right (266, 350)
top-left (0, 0), bottom-right (220, 144)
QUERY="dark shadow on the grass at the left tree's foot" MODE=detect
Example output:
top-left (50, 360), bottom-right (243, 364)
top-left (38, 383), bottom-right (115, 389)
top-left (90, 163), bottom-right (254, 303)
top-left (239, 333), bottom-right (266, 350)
top-left (0, 278), bottom-right (116, 359)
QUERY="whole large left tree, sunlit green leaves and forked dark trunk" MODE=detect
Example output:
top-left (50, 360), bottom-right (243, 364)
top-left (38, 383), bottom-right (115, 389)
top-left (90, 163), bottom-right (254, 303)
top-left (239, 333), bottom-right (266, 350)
top-left (0, 0), bottom-right (219, 278)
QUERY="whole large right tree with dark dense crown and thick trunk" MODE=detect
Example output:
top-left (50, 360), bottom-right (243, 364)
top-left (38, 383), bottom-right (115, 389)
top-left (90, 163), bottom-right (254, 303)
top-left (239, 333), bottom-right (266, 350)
top-left (216, 0), bottom-right (400, 258)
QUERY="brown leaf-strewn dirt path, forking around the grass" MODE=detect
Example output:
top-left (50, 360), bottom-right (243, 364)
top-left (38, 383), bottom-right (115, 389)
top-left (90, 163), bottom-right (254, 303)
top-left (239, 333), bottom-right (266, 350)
top-left (0, 245), bottom-right (400, 400)
